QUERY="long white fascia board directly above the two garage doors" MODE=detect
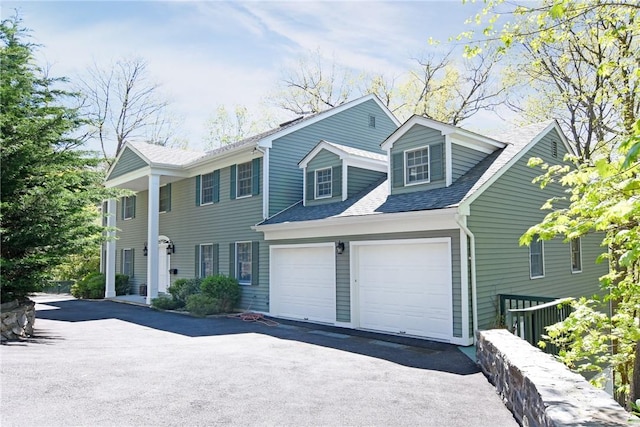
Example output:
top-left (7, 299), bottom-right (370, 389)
top-left (252, 208), bottom-right (459, 240)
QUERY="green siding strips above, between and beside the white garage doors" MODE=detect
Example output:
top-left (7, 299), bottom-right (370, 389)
top-left (263, 230), bottom-right (462, 337)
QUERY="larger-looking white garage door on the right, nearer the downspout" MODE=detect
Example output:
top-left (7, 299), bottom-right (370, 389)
top-left (355, 239), bottom-right (452, 340)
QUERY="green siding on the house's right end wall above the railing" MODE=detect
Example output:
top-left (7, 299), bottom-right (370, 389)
top-left (468, 131), bottom-right (607, 329)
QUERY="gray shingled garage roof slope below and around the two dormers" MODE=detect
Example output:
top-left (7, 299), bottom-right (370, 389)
top-left (259, 122), bottom-right (553, 225)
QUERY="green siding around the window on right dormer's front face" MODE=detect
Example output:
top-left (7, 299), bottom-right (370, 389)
top-left (390, 125), bottom-right (446, 194)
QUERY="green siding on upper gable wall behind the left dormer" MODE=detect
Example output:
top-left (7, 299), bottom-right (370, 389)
top-left (269, 100), bottom-right (396, 215)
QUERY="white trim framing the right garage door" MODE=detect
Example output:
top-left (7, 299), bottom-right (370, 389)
top-left (349, 237), bottom-right (456, 345)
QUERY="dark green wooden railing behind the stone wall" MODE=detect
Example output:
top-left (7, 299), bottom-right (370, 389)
top-left (499, 295), bottom-right (571, 354)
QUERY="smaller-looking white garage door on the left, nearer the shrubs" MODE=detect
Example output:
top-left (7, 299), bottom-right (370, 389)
top-left (269, 243), bottom-right (336, 323)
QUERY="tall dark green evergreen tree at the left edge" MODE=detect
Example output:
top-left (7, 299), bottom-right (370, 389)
top-left (0, 16), bottom-right (115, 301)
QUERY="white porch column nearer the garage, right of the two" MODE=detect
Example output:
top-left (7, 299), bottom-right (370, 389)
top-left (147, 173), bottom-right (160, 304)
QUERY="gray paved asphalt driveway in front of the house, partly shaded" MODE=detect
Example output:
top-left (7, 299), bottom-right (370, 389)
top-left (0, 297), bottom-right (517, 427)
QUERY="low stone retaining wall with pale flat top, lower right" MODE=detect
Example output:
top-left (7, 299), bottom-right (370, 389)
top-left (476, 329), bottom-right (640, 427)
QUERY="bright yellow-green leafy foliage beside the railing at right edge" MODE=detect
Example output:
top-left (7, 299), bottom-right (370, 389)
top-left (520, 121), bottom-right (640, 407)
